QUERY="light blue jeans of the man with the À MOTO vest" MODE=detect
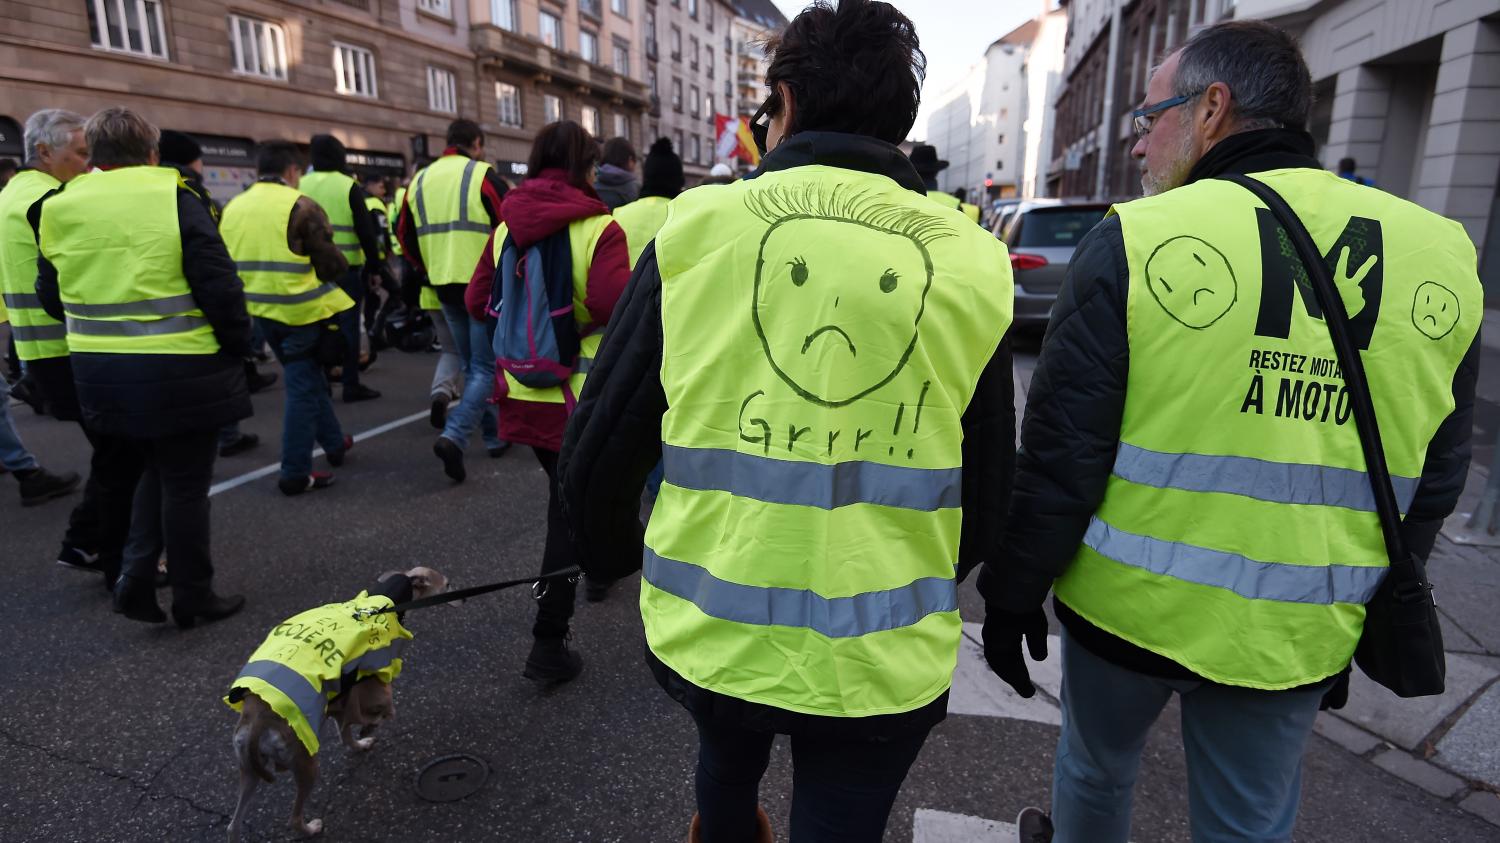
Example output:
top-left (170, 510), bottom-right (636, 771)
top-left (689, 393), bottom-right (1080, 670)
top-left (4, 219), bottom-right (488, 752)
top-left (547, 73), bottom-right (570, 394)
top-left (1052, 630), bottom-right (1329, 843)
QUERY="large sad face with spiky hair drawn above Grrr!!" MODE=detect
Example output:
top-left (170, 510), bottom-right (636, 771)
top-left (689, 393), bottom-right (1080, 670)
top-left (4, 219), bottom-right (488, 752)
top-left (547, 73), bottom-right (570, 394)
top-left (746, 185), bottom-right (954, 407)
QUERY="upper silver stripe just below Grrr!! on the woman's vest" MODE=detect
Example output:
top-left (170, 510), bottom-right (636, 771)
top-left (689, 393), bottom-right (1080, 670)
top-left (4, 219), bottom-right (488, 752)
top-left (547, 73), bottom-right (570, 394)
top-left (662, 446), bottom-right (963, 512)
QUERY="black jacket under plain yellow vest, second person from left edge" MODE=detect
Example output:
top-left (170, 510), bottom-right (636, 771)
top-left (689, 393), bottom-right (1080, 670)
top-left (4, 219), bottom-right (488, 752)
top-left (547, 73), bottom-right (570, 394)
top-left (30, 177), bottom-right (254, 440)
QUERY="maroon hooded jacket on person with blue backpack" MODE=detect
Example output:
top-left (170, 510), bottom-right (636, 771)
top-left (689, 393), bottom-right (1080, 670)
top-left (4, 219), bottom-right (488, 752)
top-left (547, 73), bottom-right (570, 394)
top-left (464, 170), bottom-right (630, 452)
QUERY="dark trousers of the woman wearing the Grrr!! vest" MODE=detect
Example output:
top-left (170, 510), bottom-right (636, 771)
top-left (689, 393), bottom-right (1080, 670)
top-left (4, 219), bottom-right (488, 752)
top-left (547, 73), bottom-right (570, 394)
top-left (693, 708), bottom-right (929, 843)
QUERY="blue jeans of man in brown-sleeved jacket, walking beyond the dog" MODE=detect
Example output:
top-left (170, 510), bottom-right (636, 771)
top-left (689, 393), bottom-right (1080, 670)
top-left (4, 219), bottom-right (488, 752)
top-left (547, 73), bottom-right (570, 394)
top-left (264, 318), bottom-right (344, 480)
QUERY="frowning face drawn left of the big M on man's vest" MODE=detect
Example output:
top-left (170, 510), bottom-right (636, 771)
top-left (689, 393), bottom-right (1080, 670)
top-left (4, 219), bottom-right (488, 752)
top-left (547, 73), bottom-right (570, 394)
top-left (1146, 236), bottom-right (1239, 330)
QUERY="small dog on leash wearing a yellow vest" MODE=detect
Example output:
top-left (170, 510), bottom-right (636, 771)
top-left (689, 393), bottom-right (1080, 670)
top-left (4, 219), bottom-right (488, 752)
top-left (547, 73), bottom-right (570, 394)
top-left (224, 567), bottom-right (449, 843)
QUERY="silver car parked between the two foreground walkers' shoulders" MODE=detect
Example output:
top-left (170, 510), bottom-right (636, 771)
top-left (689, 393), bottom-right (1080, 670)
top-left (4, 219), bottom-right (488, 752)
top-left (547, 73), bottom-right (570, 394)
top-left (995, 200), bottom-right (1110, 329)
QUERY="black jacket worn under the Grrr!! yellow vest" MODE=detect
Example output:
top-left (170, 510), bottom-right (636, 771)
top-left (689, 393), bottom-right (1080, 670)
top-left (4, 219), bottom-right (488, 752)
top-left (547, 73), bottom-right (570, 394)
top-left (558, 132), bottom-right (1016, 738)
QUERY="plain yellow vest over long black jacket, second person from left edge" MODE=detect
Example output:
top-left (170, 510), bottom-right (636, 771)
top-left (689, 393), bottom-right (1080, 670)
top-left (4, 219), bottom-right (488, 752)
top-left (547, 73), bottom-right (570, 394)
top-left (41, 167), bottom-right (219, 354)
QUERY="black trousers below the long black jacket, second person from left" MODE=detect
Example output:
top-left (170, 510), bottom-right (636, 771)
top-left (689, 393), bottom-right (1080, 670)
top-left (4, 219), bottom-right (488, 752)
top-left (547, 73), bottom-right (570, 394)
top-left (96, 429), bottom-right (219, 599)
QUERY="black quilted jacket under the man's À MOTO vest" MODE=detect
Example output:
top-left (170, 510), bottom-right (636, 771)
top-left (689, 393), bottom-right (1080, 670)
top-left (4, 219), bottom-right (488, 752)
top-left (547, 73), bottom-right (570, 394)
top-left (978, 129), bottom-right (1479, 678)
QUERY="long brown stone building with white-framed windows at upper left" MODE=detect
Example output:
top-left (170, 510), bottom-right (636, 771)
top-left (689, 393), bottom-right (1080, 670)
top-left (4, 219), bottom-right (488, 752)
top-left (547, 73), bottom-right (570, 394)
top-left (0, 0), bottom-right (648, 201)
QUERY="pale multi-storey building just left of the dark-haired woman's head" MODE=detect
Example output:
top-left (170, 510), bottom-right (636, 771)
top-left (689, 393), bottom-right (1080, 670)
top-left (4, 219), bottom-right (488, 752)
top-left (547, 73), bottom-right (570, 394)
top-left (638, 0), bottom-right (734, 178)
